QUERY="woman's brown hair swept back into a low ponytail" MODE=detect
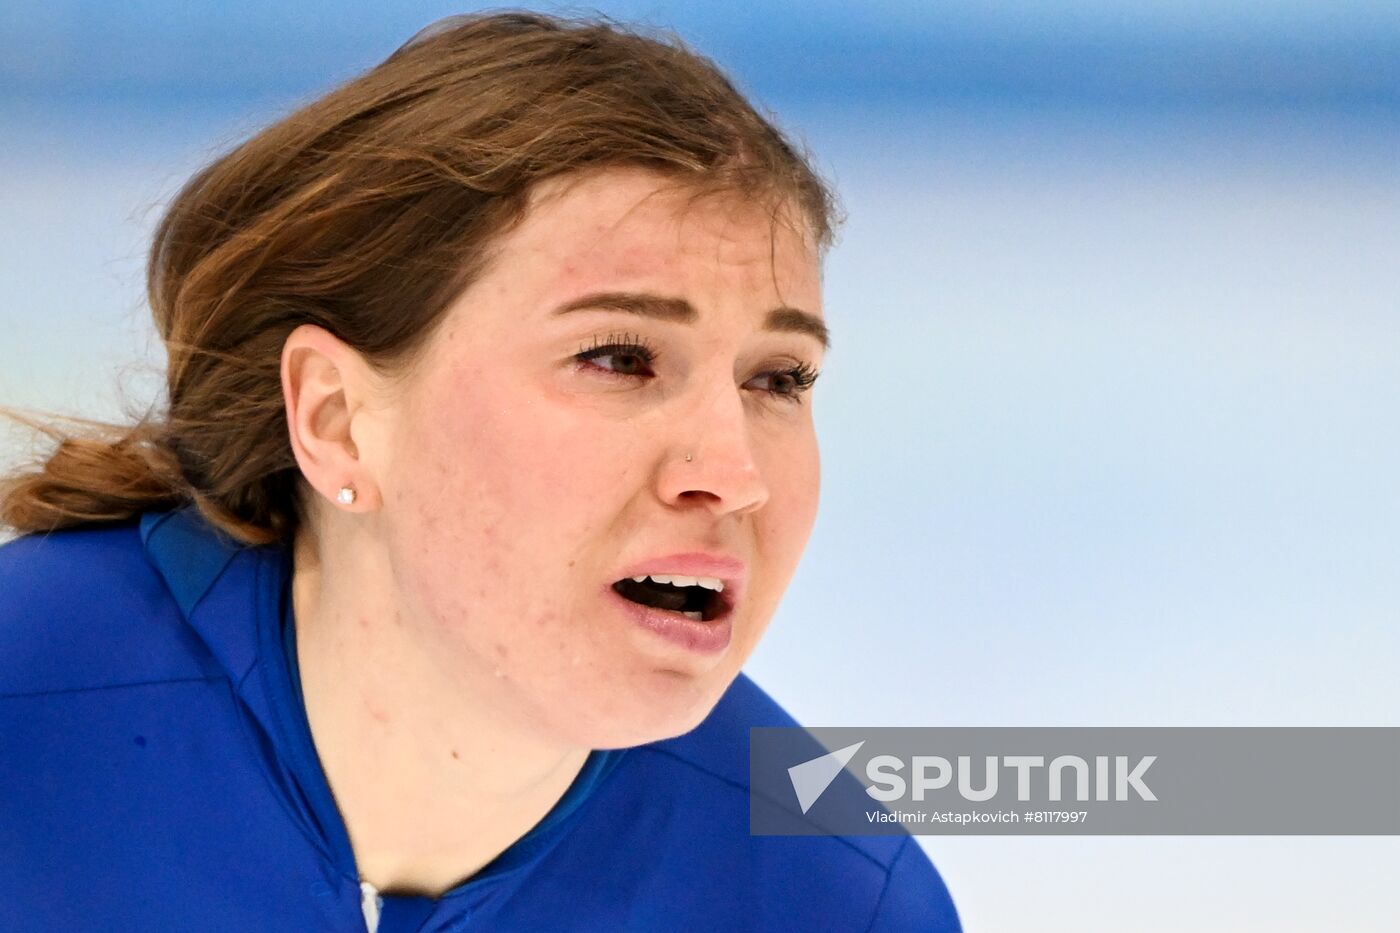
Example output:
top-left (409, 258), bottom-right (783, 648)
top-left (0, 13), bottom-right (834, 544)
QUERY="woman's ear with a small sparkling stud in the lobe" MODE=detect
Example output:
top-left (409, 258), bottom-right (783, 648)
top-left (281, 324), bottom-right (379, 511)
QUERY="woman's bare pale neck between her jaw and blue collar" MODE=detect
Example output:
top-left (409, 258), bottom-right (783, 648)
top-left (293, 515), bottom-right (589, 897)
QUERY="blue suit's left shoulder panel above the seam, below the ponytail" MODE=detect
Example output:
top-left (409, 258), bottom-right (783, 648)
top-left (0, 520), bottom-right (215, 696)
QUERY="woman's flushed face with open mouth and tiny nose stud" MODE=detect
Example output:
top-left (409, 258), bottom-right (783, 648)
top-left (372, 170), bottom-right (825, 748)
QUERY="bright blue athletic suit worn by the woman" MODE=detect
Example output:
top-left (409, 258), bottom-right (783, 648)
top-left (0, 507), bottom-right (960, 933)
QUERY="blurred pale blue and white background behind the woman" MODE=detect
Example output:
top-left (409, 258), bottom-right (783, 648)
top-left (0, 0), bottom-right (1400, 932)
